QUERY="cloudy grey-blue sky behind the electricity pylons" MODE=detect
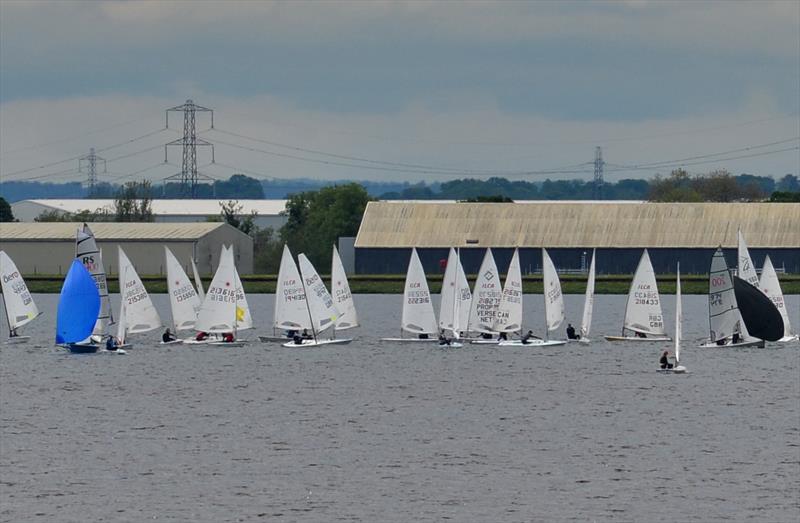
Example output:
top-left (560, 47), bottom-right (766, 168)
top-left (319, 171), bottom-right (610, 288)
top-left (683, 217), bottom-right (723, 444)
top-left (0, 0), bottom-right (800, 183)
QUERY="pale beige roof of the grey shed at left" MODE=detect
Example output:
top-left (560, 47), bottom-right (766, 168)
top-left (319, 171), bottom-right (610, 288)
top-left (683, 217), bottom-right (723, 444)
top-left (0, 222), bottom-right (231, 241)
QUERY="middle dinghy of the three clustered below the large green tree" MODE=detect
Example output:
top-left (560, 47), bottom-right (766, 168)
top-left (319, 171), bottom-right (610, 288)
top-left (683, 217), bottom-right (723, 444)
top-left (283, 253), bottom-right (353, 347)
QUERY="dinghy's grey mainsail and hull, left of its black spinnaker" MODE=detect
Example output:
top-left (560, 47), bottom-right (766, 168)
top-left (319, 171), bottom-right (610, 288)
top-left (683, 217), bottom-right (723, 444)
top-left (700, 247), bottom-right (764, 347)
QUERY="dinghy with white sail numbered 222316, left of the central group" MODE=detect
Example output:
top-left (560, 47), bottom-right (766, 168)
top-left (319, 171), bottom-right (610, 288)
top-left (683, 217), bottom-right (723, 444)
top-left (381, 248), bottom-right (438, 342)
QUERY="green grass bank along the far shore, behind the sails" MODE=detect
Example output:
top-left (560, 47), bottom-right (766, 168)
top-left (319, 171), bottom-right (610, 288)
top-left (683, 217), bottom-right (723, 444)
top-left (17, 274), bottom-right (800, 294)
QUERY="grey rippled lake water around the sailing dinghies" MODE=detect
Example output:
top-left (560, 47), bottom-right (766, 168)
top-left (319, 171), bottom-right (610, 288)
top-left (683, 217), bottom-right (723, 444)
top-left (0, 295), bottom-right (800, 522)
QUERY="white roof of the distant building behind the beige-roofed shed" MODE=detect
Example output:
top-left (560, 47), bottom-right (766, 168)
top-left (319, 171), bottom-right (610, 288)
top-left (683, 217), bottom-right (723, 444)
top-left (11, 199), bottom-right (286, 216)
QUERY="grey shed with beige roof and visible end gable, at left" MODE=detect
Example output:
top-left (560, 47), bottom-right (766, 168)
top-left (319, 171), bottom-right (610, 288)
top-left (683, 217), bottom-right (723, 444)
top-left (0, 222), bottom-right (253, 275)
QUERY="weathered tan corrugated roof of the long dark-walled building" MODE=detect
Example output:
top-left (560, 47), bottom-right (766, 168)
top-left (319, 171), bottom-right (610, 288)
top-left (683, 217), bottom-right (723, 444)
top-left (355, 202), bottom-right (800, 248)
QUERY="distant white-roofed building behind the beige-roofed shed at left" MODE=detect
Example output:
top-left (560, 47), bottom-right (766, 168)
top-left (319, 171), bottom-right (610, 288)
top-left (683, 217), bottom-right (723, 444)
top-left (11, 199), bottom-right (288, 230)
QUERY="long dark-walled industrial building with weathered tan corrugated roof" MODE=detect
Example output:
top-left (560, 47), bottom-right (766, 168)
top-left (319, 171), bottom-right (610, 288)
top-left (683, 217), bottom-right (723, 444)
top-left (355, 201), bottom-right (800, 274)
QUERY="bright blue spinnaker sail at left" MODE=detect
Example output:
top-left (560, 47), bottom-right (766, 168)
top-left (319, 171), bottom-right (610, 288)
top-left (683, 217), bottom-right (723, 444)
top-left (56, 259), bottom-right (100, 344)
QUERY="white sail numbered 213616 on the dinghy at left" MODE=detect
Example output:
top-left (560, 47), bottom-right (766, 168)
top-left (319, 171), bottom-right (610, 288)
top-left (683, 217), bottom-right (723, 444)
top-left (194, 246), bottom-right (236, 333)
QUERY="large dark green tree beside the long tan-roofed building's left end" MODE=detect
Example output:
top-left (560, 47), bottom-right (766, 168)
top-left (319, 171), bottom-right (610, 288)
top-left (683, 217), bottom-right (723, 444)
top-left (280, 183), bottom-right (371, 272)
